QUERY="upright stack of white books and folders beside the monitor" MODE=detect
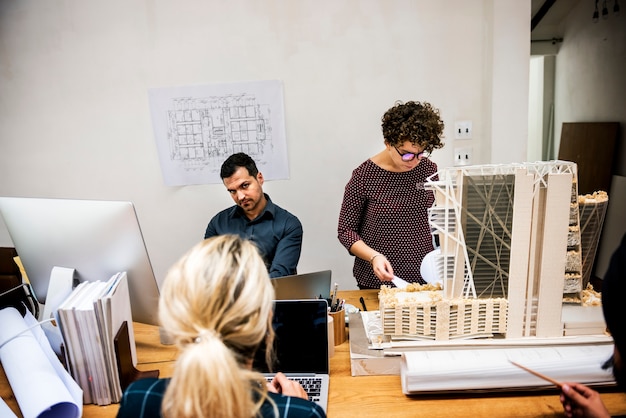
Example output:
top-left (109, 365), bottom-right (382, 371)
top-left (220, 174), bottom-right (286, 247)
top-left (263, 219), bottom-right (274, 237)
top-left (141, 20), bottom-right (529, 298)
top-left (55, 272), bottom-right (137, 405)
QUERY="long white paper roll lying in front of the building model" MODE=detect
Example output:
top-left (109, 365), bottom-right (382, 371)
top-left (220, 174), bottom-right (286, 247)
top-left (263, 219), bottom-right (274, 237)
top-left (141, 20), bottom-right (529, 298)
top-left (400, 344), bottom-right (614, 395)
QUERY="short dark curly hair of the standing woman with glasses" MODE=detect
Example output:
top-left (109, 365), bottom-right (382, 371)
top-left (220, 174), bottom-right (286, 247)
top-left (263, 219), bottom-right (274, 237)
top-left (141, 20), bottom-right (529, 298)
top-left (382, 101), bottom-right (444, 152)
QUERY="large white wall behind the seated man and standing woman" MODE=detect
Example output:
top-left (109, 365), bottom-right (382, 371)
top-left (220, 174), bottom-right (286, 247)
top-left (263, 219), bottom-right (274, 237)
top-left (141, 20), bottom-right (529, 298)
top-left (0, 0), bottom-right (530, 289)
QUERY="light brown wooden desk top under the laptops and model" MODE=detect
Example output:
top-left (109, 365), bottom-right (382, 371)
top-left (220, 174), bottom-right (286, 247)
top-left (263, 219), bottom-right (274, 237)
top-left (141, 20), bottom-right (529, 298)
top-left (0, 291), bottom-right (626, 418)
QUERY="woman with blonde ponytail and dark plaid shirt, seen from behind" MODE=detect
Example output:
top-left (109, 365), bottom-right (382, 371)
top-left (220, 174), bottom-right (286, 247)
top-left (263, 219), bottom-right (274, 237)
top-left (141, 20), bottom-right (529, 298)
top-left (117, 235), bottom-right (325, 418)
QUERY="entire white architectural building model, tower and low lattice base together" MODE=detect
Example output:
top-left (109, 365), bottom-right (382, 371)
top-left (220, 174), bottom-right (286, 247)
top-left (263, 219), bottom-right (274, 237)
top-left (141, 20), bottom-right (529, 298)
top-left (379, 161), bottom-right (600, 340)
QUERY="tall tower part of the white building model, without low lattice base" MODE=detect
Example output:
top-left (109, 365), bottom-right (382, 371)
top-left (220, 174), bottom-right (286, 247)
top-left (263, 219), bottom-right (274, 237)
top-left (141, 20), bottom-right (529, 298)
top-left (425, 161), bottom-right (580, 338)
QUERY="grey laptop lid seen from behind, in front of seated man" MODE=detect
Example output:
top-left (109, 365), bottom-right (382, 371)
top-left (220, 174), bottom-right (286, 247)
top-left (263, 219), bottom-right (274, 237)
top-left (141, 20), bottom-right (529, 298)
top-left (272, 270), bottom-right (331, 300)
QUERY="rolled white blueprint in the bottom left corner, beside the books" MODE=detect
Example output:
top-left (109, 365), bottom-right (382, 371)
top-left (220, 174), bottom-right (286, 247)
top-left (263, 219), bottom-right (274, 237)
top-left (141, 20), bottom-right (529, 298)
top-left (0, 308), bottom-right (83, 418)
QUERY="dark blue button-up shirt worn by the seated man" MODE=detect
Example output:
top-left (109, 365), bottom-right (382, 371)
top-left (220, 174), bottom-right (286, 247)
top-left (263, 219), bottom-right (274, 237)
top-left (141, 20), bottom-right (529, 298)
top-left (204, 194), bottom-right (302, 277)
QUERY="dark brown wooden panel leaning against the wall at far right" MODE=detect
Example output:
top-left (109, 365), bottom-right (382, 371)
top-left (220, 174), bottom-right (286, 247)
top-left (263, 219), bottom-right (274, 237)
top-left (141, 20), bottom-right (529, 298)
top-left (558, 122), bottom-right (619, 198)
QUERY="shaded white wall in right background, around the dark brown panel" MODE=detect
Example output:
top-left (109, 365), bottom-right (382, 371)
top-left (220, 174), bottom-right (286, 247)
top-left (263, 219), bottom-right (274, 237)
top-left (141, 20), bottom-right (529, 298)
top-left (554, 2), bottom-right (626, 278)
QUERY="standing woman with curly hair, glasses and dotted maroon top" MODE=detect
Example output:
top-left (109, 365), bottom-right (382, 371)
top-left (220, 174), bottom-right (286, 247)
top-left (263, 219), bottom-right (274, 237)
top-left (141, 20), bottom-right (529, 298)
top-left (337, 101), bottom-right (444, 289)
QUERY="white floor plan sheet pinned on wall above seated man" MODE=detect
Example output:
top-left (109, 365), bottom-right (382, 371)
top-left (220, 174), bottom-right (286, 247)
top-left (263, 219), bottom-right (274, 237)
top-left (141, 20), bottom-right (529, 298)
top-left (149, 80), bottom-right (289, 186)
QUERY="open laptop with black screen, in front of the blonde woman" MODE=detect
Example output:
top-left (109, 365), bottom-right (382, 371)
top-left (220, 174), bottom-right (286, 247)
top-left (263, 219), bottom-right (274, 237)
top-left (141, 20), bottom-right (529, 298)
top-left (253, 299), bottom-right (330, 412)
